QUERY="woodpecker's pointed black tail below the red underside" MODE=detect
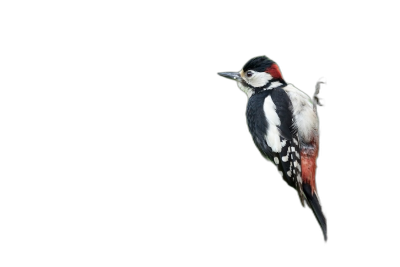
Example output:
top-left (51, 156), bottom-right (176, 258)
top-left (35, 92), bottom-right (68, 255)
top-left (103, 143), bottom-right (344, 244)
top-left (303, 183), bottom-right (328, 243)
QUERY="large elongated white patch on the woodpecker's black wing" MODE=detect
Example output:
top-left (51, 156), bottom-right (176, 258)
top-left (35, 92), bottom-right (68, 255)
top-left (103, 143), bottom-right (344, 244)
top-left (263, 96), bottom-right (282, 152)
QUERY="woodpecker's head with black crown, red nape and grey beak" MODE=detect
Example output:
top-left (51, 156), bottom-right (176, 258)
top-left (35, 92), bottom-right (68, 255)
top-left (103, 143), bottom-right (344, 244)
top-left (217, 56), bottom-right (286, 98)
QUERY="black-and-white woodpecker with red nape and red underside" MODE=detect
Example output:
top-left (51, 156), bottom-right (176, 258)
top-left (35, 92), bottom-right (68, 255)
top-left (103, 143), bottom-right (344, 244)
top-left (217, 55), bottom-right (328, 243)
